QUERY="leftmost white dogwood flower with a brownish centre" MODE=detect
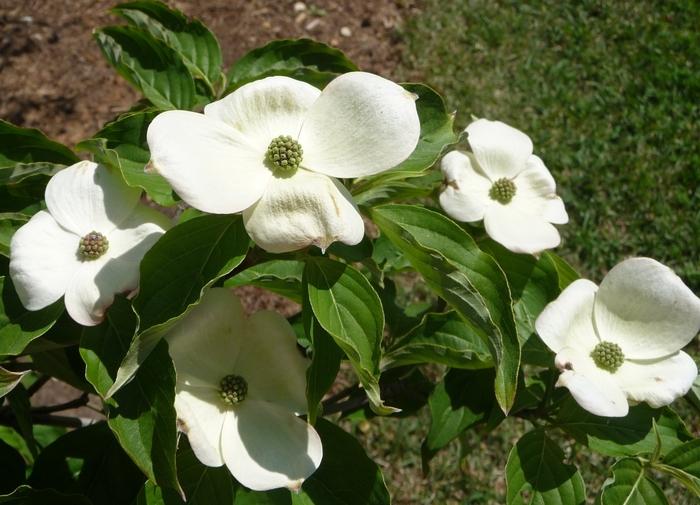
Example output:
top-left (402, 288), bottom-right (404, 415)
top-left (10, 161), bottom-right (170, 326)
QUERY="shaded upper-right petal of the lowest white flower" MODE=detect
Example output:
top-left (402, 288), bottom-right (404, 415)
top-left (235, 310), bottom-right (309, 414)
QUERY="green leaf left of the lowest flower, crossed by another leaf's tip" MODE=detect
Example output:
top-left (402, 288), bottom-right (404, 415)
top-left (80, 296), bottom-right (179, 490)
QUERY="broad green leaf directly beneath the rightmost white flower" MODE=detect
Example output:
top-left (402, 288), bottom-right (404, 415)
top-left (554, 396), bottom-right (691, 457)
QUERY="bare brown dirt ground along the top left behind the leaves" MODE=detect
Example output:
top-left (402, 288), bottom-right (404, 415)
top-left (0, 0), bottom-right (412, 145)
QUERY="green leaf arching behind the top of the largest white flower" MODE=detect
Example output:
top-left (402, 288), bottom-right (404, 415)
top-left (225, 39), bottom-right (357, 93)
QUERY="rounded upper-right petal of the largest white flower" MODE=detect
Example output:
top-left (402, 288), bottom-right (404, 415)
top-left (299, 72), bottom-right (420, 177)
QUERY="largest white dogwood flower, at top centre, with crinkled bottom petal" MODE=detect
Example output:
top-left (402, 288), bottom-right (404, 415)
top-left (148, 72), bottom-right (420, 253)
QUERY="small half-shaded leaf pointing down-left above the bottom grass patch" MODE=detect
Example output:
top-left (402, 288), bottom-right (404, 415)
top-left (421, 368), bottom-right (496, 460)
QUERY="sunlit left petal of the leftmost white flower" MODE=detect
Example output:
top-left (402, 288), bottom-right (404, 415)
top-left (10, 210), bottom-right (80, 310)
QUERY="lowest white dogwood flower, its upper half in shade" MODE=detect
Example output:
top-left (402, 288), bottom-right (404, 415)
top-left (166, 288), bottom-right (323, 491)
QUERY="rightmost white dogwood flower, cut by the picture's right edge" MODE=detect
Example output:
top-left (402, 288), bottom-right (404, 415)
top-left (535, 258), bottom-right (700, 417)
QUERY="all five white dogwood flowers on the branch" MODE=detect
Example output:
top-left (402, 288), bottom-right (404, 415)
top-left (10, 65), bottom-right (700, 490)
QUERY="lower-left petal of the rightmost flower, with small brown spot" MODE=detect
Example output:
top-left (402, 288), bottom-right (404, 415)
top-left (555, 348), bottom-right (629, 417)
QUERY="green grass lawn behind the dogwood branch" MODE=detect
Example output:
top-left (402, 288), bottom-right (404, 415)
top-left (355, 0), bottom-right (700, 505)
